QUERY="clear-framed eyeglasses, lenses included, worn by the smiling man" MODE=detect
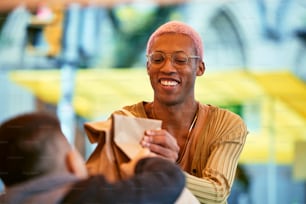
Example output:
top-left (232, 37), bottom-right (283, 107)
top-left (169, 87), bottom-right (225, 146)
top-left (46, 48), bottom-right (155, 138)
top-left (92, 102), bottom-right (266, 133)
top-left (147, 51), bottom-right (200, 67)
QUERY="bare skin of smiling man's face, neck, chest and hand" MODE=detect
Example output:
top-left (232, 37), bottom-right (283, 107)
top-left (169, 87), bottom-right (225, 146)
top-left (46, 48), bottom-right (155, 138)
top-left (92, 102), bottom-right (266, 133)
top-left (141, 33), bottom-right (205, 162)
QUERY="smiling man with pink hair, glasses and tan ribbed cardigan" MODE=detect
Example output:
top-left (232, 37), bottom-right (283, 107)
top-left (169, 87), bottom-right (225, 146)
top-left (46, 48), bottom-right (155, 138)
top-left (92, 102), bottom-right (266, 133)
top-left (85, 21), bottom-right (248, 203)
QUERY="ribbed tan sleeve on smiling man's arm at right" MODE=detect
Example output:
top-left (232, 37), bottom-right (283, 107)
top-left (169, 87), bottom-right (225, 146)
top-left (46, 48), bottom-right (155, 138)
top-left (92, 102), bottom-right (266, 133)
top-left (185, 111), bottom-right (248, 204)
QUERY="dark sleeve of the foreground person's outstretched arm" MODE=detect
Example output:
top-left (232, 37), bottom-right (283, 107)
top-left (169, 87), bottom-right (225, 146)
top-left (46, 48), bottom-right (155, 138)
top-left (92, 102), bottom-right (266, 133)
top-left (62, 158), bottom-right (185, 204)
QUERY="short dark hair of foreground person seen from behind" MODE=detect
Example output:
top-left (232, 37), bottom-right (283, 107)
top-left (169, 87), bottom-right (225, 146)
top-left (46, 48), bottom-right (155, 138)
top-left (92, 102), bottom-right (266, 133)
top-left (0, 112), bottom-right (69, 186)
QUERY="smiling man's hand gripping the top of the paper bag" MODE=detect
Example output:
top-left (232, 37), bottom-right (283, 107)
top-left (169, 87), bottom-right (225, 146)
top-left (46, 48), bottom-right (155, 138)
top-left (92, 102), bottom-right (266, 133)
top-left (140, 129), bottom-right (180, 162)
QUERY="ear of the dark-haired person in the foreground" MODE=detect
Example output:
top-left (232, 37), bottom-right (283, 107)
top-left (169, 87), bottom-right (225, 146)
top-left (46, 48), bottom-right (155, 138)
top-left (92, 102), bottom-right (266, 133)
top-left (66, 149), bottom-right (88, 178)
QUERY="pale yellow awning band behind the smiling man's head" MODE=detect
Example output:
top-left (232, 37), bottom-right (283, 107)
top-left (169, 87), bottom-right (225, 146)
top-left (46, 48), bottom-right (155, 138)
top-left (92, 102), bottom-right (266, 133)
top-left (11, 68), bottom-right (262, 120)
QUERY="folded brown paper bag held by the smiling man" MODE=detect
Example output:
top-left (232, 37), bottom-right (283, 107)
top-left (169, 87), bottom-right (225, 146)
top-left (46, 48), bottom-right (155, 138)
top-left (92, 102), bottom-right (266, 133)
top-left (84, 114), bottom-right (161, 182)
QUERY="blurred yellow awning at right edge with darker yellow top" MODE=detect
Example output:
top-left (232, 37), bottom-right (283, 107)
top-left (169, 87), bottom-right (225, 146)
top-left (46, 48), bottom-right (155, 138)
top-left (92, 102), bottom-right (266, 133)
top-left (241, 71), bottom-right (306, 164)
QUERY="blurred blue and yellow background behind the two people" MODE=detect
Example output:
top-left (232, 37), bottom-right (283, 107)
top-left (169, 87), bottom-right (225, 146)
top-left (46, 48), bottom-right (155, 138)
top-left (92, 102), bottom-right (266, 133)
top-left (0, 0), bottom-right (306, 204)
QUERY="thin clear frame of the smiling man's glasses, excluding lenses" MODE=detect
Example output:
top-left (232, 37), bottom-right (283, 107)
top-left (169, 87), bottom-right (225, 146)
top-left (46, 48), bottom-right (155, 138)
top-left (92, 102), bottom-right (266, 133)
top-left (146, 51), bottom-right (201, 67)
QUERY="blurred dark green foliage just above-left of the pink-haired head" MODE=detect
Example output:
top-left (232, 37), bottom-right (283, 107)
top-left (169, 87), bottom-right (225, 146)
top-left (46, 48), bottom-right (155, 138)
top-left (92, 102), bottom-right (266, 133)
top-left (108, 5), bottom-right (178, 68)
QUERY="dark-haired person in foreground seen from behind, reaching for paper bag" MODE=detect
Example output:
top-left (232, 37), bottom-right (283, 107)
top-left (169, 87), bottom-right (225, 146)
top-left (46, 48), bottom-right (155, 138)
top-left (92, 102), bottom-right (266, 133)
top-left (0, 113), bottom-right (185, 204)
